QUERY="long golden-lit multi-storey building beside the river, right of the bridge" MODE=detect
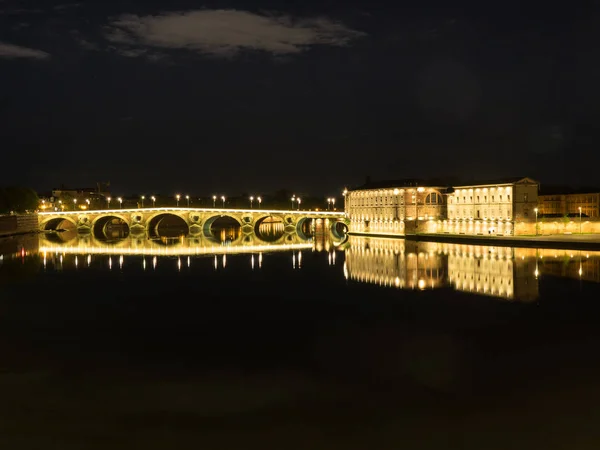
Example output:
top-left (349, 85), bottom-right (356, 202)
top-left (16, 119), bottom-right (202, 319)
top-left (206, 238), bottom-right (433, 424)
top-left (346, 178), bottom-right (539, 236)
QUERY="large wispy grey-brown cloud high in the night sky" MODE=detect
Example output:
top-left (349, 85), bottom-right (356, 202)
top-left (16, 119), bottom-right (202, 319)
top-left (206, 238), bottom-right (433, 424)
top-left (106, 10), bottom-right (364, 56)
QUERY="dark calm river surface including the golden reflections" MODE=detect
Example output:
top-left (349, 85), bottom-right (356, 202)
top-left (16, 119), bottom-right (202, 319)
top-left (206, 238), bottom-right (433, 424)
top-left (0, 230), bottom-right (600, 450)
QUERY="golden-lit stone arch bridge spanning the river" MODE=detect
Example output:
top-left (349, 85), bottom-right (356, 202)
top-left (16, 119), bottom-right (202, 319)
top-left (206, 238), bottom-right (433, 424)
top-left (38, 208), bottom-right (347, 241)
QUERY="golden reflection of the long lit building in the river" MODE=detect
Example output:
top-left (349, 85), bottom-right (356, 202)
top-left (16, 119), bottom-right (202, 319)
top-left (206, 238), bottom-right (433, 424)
top-left (345, 236), bottom-right (576, 301)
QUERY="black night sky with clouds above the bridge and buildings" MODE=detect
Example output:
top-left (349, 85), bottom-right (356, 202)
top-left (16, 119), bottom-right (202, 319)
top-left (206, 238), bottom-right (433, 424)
top-left (0, 0), bottom-right (600, 195)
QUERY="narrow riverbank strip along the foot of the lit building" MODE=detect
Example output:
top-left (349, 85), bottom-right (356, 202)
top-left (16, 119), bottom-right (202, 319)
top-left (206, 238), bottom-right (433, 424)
top-left (348, 232), bottom-right (600, 250)
